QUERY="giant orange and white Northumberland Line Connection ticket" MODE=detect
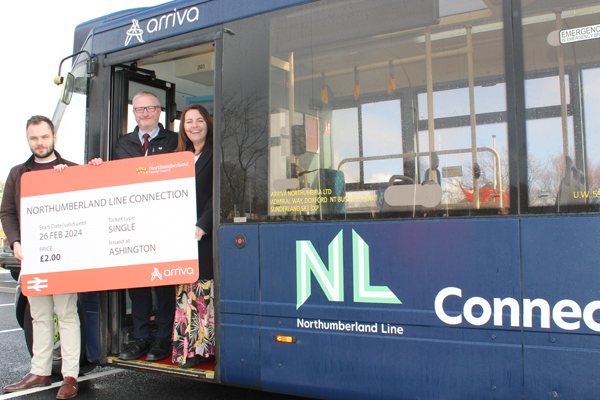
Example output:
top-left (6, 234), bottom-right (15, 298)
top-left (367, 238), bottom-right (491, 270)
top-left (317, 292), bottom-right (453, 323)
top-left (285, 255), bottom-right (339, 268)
top-left (21, 152), bottom-right (198, 296)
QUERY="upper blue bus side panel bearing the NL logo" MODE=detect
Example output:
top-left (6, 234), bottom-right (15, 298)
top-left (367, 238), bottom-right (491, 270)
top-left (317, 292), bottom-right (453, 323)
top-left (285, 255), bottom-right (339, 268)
top-left (260, 218), bottom-right (520, 328)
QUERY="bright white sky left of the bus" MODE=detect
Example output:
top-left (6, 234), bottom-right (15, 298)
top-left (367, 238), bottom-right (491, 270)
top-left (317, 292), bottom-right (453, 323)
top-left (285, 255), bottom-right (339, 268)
top-left (0, 0), bottom-right (168, 182)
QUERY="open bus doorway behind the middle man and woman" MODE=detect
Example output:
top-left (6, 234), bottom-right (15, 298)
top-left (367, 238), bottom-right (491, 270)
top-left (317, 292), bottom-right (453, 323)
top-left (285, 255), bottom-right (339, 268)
top-left (104, 42), bottom-right (215, 380)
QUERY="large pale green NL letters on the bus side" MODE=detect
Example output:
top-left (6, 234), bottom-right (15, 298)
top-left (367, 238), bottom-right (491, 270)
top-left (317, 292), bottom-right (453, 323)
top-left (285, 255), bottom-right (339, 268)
top-left (296, 229), bottom-right (402, 309)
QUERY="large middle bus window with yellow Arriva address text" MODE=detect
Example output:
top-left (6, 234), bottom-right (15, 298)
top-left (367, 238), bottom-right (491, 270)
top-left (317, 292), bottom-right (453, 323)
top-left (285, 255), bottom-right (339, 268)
top-left (268, 0), bottom-right (509, 220)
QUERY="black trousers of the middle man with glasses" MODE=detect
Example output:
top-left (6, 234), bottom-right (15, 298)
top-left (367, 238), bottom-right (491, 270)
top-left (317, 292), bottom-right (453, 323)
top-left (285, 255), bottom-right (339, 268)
top-left (129, 286), bottom-right (175, 341)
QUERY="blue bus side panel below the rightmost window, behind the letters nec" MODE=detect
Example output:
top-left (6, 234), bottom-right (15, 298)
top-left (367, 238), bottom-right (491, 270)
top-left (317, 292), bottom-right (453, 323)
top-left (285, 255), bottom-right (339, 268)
top-left (521, 216), bottom-right (600, 398)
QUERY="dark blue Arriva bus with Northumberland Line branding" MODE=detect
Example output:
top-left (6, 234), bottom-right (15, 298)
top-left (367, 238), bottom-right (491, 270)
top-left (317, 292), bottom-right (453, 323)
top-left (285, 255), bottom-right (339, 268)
top-left (17, 0), bottom-right (600, 400)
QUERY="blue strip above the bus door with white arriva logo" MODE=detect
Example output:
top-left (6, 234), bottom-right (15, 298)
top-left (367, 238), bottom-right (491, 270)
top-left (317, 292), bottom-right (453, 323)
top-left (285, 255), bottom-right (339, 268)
top-left (74, 0), bottom-right (316, 55)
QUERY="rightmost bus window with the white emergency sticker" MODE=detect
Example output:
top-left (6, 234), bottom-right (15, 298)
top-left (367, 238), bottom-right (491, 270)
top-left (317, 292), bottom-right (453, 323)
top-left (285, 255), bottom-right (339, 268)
top-left (523, 0), bottom-right (600, 213)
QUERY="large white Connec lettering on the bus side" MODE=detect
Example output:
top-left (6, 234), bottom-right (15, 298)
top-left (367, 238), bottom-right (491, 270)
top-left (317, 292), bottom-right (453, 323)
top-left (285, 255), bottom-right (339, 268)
top-left (435, 287), bottom-right (600, 332)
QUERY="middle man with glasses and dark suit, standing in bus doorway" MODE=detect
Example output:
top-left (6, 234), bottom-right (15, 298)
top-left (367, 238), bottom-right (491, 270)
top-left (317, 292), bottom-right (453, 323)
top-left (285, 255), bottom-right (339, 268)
top-left (114, 92), bottom-right (177, 361)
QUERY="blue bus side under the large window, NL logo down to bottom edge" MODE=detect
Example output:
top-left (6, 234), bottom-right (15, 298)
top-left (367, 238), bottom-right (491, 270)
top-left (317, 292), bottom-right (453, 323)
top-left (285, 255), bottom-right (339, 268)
top-left (251, 218), bottom-right (523, 399)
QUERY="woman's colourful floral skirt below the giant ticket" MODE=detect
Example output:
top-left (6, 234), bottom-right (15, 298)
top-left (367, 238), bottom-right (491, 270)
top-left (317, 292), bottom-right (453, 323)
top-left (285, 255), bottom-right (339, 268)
top-left (173, 279), bottom-right (215, 364)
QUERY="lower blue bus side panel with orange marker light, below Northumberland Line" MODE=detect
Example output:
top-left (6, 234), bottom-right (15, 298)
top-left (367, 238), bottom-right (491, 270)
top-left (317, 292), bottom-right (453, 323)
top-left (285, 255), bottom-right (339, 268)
top-left (261, 317), bottom-right (523, 400)
